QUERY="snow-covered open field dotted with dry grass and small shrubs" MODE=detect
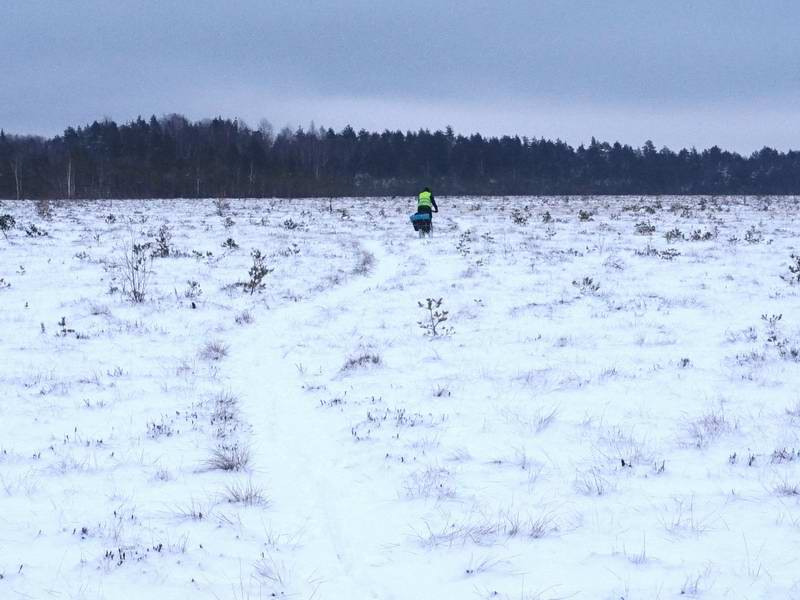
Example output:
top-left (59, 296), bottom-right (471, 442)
top-left (0, 197), bottom-right (800, 600)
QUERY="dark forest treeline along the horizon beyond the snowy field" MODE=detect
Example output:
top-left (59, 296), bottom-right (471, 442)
top-left (0, 114), bottom-right (800, 199)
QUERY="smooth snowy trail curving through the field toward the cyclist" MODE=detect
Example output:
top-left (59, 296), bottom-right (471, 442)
top-left (230, 240), bottom-right (422, 598)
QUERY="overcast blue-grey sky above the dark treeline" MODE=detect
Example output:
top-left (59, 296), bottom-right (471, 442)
top-left (0, 0), bottom-right (800, 152)
